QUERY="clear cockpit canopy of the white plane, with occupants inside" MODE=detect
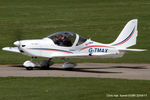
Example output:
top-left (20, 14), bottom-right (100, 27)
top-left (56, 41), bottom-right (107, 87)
top-left (48, 32), bottom-right (87, 47)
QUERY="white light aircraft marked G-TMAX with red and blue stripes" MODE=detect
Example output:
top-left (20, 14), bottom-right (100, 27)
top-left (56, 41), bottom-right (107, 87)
top-left (2, 19), bottom-right (145, 70)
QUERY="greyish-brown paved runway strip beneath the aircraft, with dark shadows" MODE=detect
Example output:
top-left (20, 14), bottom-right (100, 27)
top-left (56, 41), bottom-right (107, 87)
top-left (0, 63), bottom-right (150, 80)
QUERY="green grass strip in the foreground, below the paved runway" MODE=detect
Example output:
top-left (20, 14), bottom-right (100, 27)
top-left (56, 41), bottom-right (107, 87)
top-left (0, 77), bottom-right (150, 100)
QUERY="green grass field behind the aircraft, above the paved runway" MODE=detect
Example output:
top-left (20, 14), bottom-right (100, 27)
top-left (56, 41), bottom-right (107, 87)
top-left (0, 0), bottom-right (150, 64)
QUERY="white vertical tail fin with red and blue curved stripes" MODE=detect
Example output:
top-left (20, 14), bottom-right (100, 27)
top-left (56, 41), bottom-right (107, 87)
top-left (110, 19), bottom-right (138, 48)
